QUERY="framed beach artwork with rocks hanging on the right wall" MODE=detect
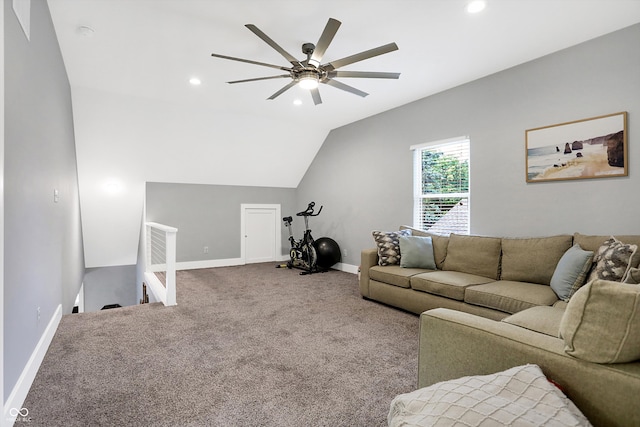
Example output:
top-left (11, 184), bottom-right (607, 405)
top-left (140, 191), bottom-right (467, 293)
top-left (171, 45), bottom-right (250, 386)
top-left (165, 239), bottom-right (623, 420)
top-left (525, 111), bottom-right (629, 182)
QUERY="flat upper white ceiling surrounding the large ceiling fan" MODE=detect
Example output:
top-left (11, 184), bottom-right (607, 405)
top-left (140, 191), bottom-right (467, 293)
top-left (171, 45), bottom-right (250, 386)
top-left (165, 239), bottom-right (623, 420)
top-left (49, 0), bottom-right (640, 133)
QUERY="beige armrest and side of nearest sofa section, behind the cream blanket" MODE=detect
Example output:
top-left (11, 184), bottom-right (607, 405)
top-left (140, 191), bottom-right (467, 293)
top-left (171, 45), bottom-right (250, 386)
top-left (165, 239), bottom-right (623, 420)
top-left (418, 308), bottom-right (640, 426)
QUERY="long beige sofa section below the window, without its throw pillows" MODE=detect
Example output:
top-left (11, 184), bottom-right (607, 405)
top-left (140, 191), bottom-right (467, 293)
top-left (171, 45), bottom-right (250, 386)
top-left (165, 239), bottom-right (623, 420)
top-left (359, 226), bottom-right (640, 320)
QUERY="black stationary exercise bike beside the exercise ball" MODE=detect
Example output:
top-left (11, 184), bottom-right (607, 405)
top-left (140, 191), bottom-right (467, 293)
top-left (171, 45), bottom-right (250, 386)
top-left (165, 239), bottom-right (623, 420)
top-left (277, 202), bottom-right (327, 275)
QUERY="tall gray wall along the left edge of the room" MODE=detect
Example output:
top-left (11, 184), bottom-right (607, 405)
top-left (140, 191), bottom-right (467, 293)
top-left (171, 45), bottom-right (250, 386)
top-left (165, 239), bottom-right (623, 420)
top-left (3, 1), bottom-right (84, 397)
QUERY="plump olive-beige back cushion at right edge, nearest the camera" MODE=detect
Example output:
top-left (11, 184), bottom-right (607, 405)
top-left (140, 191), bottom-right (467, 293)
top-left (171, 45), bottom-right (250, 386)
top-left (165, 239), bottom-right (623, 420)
top-left (560, 280), bottom-right (640, 363)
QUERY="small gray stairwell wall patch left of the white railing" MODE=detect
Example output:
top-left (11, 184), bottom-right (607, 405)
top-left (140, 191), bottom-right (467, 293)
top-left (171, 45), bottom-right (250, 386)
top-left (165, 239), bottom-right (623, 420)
top-left (84, 265), bottom-right (139, 311)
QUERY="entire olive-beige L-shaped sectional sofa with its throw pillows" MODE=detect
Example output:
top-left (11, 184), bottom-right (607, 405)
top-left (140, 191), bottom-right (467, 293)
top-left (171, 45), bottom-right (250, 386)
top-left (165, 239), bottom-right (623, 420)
top-left (360, 227), bottom-right (640, 426)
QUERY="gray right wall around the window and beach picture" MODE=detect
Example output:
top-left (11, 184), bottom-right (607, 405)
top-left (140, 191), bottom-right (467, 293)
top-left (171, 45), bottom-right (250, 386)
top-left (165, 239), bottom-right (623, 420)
top-left (296, 25), bottom-right (640, 265)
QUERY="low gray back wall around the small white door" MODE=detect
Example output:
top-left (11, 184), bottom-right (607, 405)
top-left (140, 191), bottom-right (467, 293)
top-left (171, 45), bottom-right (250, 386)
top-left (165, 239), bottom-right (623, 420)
top-left (146, 182), bottom-right (298, 262)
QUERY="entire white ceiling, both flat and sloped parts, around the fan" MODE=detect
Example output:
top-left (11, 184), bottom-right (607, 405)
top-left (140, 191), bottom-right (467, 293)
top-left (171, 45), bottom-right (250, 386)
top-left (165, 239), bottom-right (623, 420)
top-left (48, 0), bottom-right (640, 267)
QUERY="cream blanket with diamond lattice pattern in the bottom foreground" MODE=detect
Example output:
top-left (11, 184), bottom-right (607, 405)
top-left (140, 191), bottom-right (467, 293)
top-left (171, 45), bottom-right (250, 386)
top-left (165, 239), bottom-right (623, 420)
top-left (387, 365), bottom-right (591, 427)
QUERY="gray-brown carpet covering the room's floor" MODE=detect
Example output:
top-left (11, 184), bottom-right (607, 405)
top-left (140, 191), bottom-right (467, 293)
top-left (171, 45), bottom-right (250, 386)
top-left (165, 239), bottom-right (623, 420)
top-left (23, 263), bottom-right (418, 427)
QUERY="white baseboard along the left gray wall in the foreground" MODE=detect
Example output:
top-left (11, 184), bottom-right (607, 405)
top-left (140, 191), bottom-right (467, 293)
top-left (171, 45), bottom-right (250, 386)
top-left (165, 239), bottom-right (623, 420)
top-left (4, 304), bottom-right (62, 425)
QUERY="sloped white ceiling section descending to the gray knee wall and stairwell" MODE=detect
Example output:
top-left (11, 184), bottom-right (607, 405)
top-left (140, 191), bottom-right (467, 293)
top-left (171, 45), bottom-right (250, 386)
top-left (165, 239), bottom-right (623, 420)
top-left (73, 88), bottom-right (326, 267)
